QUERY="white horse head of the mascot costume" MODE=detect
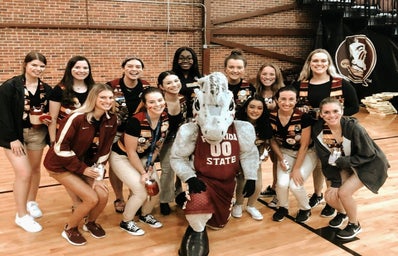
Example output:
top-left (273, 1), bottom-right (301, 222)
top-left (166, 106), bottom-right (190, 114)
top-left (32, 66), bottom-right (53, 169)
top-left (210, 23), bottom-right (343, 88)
top-left (193, 72), bottom-right (235, 144)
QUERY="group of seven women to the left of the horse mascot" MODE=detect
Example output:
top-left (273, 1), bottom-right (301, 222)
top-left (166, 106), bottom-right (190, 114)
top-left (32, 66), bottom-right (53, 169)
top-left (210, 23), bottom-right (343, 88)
top-left (0, 47), bottom-right (199, 245)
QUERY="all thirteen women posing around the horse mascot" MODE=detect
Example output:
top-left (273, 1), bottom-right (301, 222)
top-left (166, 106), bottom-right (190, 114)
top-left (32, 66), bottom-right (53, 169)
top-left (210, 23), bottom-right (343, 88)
top-left (0, 47), bottom-right (389, 245)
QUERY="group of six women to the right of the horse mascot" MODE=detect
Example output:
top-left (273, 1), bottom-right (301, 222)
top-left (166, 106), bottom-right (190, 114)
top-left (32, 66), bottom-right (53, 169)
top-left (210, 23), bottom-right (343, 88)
top-left (225, 49), bottom-right (389, 239)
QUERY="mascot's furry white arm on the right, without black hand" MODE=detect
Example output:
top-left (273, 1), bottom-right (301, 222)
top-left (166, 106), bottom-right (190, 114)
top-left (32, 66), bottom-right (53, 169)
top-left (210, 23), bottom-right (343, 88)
top-left (234, 120), bottom-right (260, 180)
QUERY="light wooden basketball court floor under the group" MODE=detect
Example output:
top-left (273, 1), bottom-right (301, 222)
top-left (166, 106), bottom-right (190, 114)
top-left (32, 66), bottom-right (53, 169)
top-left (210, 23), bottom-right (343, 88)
top-left (0, 109), bottom-right (398, 256)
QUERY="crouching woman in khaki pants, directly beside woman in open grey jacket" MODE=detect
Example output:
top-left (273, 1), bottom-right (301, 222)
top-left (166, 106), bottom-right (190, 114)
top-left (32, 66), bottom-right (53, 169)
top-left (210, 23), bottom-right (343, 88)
top-left (270, 86), bottom-right (316, 223)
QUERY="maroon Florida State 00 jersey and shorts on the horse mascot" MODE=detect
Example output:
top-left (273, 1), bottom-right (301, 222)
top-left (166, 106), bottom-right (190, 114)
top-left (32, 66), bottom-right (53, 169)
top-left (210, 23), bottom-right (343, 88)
top-left (185, 125), bottom-right (240, 228)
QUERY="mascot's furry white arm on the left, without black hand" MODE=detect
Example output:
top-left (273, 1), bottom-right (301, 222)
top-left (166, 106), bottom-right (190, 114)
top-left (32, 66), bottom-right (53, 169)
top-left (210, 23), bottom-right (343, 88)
top-left (170, 123), bottom-right (199, 182)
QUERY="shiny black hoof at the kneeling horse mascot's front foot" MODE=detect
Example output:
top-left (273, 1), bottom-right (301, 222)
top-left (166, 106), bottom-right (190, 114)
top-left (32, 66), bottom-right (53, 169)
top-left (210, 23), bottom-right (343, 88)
top-left (178, 226), bottom-right (209, 256)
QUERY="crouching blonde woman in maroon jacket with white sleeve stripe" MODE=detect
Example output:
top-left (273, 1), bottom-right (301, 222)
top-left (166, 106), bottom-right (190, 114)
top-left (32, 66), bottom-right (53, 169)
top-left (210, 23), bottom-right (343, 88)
top-left (44, 84), bottom-right (117, 245)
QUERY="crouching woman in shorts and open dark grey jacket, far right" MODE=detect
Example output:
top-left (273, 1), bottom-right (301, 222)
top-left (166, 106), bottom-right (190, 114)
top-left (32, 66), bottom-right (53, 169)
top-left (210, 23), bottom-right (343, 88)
top-left (313, 98), bottom-right (390, 239)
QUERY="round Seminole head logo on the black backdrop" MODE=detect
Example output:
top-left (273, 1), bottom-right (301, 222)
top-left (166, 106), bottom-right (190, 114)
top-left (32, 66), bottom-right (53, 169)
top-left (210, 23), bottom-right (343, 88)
top-left (336, 35), bottom-right (377, 86)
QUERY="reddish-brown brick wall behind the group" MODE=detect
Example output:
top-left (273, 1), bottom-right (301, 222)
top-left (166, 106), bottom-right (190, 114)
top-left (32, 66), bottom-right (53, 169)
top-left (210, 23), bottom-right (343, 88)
top-left (0, 0), bottom-right (313, 85)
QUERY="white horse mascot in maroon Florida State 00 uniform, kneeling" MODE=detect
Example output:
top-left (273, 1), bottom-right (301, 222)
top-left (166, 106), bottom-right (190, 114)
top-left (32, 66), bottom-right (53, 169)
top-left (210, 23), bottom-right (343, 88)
top-left (170, 72), bottom-right (259, 256)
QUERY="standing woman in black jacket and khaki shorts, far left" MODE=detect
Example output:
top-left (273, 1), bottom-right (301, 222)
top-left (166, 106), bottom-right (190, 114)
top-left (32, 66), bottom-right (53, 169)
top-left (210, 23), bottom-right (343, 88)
top-left (0, 51), bottom-right (51, 232)
